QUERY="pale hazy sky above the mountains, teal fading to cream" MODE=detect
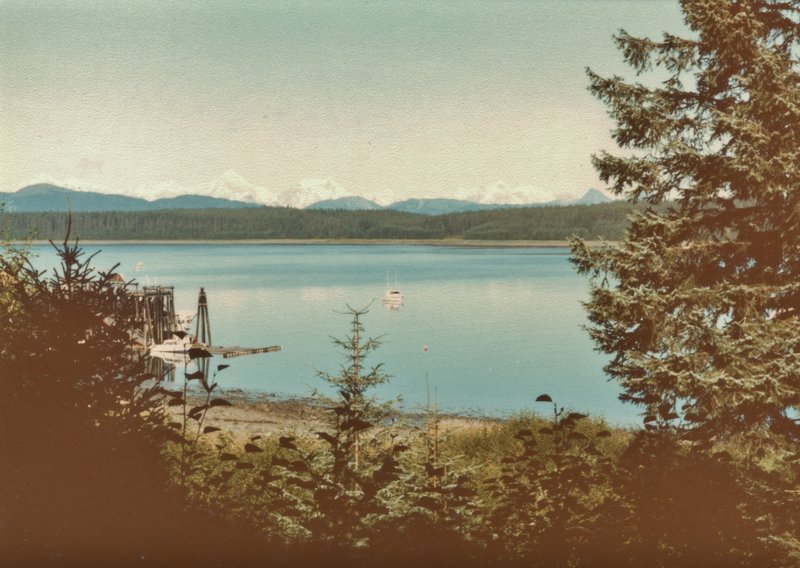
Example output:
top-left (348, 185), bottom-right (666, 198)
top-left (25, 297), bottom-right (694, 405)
top-left (0, 0), bottom-right (685, 202)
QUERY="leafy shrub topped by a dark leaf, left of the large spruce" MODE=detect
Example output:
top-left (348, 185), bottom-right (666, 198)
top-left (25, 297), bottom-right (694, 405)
top-left (486, 395), bottom-right (616, 566)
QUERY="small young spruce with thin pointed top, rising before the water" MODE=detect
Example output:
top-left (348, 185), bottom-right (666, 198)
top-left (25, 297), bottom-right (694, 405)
top-left (206, 306), bottom-right (408, 557)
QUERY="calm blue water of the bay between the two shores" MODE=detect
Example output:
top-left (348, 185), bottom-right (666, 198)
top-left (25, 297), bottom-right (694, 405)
top-left (31, 245), bottom-right (636, 423)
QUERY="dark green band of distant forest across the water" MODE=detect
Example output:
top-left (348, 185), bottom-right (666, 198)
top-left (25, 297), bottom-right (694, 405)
top-left (4, 202), bottom-right (633, 240)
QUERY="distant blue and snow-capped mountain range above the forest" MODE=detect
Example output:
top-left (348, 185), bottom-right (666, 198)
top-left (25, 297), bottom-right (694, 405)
top-left (0, 183), bottom-right (612, 215)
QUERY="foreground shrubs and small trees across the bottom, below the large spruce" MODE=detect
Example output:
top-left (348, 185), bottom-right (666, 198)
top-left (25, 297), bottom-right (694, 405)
top-left (10, 232), bottom-right (798, 566)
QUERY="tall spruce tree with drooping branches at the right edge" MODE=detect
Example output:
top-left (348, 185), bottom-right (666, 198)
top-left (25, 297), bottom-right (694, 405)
top-left (572, 0), bottom-right (800, 451)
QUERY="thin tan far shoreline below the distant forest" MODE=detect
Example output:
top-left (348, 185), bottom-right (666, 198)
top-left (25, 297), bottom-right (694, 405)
top-left (23, 239), bottom-right (611, 248)
